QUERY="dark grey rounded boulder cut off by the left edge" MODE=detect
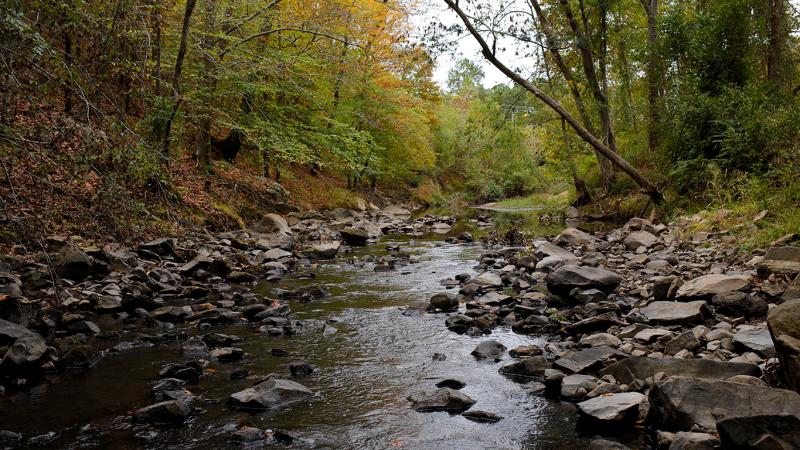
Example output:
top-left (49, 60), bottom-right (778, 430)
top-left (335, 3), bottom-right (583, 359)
top-left (0, 319), bottom-right (47, 373)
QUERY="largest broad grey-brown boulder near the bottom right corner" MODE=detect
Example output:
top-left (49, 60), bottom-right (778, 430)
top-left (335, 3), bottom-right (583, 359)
top-left (650, 377), bottom-right (800, 431)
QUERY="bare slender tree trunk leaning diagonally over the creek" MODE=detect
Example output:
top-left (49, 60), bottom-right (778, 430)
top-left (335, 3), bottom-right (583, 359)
top-left (444, 0), bottom-right (663, 203)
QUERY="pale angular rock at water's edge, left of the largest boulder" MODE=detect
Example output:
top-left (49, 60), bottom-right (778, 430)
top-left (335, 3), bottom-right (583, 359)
top-left (578, 392), bottom-right (650, 425)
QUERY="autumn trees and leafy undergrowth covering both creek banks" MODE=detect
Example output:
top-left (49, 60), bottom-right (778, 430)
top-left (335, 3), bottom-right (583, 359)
top-left (0, 0), bottom-right (800, 250)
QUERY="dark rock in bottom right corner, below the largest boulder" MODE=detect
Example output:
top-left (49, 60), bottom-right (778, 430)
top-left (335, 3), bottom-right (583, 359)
top-left (717, 415), bottom-right (800, 450)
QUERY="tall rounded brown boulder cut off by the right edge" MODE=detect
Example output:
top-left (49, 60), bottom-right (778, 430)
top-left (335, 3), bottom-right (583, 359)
top-left (767, 299), bottom-right (800, 391)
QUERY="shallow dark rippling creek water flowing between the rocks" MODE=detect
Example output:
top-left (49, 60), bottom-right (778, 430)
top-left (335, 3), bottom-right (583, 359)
top-left (0, 232), bottom-right (588, 449)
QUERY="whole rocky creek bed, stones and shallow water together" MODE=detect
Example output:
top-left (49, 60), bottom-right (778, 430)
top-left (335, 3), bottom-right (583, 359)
top-left (0, 207), bottom-right (800, 449)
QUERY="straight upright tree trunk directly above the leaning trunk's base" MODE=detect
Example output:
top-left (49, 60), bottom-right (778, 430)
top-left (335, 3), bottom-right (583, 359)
top-left (641, 0), bottom-right (663, 153)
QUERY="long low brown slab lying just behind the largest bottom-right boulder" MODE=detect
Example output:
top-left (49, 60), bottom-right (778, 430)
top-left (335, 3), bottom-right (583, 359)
top-left (600, 357), bottom-right (761, 384)
